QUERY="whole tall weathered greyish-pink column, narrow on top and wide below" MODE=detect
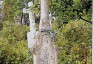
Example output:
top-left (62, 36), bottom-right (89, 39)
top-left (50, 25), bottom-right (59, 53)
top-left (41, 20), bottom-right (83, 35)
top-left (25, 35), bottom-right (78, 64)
top-left (32, 0), bottom-right (58, 64)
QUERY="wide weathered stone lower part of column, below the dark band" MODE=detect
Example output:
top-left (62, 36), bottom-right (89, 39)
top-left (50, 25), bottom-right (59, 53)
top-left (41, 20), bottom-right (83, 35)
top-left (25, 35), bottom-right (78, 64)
top-left (32, 32), bottom-right (58, 64)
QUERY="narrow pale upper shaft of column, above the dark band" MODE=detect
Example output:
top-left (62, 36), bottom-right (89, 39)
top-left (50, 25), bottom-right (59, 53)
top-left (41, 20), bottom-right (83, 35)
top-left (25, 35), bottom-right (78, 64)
top-left (39, 0), bottom-right (51, 31)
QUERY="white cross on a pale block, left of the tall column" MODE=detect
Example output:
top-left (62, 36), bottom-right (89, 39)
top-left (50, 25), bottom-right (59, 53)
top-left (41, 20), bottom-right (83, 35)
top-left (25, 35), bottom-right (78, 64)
top-left (23, 2), bottom-right (36, 49)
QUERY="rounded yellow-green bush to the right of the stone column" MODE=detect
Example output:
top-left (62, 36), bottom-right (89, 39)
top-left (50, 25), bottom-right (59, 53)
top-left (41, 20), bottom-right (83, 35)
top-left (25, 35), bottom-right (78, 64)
top-left (53, 20), bottom-right (92, 64)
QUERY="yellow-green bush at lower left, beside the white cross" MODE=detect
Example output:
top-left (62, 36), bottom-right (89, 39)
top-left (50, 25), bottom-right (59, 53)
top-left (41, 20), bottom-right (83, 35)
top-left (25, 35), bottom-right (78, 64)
top-left (0, 21), bottom-right (32, 64)
